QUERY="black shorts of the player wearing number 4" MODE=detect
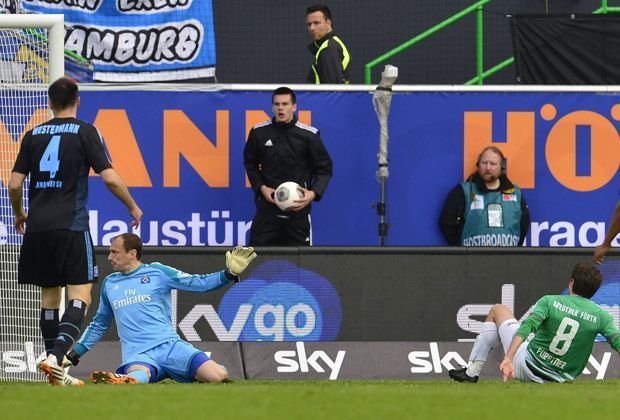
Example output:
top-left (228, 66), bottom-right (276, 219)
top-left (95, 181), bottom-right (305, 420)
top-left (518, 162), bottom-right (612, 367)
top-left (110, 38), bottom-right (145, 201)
top-left (17, 230), bottom-right (99, 287)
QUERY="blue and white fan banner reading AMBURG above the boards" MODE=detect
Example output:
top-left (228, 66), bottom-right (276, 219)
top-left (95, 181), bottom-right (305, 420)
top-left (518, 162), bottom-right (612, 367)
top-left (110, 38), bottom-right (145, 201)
top-left (22, 0), bottom-right (215, 82)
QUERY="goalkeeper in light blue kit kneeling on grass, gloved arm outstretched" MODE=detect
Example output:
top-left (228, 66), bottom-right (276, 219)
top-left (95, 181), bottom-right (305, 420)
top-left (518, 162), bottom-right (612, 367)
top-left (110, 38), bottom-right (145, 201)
top-left (60, 233), bottom-right (256, 384)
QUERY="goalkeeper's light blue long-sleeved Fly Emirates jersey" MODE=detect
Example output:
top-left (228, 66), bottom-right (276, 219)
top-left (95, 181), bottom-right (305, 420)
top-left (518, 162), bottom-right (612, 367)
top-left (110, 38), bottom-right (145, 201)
top-left (74, 263), bottom-right (229, 363)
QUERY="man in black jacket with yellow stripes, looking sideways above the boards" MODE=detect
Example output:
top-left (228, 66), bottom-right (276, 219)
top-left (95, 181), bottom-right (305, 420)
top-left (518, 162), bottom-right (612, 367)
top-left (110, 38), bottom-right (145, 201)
top-left (306, 4), bottom-right (351, 85)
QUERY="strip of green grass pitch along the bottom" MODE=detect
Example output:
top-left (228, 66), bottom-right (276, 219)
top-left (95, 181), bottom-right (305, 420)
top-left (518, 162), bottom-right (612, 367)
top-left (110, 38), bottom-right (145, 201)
top-left (0, 379), bottom-right (620, 420)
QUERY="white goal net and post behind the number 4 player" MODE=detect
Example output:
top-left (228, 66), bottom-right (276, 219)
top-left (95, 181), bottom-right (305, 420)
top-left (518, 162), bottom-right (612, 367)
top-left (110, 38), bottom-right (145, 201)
top-left (0, 15), bottom-right (64, 381)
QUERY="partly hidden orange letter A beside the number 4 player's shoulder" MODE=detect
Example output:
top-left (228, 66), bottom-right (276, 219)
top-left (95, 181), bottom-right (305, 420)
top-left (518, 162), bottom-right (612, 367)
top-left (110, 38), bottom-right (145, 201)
top-left (90, 109), bottom-right (153, 187)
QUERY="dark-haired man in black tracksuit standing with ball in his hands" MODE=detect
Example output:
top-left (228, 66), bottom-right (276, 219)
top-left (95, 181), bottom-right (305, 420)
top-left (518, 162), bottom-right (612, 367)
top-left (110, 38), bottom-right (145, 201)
top-left (243, 87), bottom-right (332, 246)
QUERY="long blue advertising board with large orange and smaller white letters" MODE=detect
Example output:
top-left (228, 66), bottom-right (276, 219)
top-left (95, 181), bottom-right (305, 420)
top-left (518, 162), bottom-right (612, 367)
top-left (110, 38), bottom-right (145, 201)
top-left (5, 90), bottom-right (620, 247)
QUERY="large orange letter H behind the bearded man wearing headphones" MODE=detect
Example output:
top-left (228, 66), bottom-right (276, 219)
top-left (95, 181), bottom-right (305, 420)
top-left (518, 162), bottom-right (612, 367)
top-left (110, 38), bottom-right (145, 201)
top-left (463, 112), bottom-right (535, 188)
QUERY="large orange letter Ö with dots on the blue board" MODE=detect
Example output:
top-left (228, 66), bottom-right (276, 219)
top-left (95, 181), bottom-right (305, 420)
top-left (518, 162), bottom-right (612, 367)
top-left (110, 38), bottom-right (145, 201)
top-left (543, 109), bottom-right (620, 192)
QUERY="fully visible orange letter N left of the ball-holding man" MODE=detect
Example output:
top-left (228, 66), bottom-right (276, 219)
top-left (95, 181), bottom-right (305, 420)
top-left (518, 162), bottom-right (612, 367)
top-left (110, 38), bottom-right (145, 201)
top-left (164, 110), bottom-right (230, 188)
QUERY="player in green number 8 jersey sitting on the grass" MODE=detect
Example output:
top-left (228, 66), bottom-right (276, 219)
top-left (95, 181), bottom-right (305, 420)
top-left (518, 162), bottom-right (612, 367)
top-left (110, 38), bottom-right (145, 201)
top-left (448, 262), bottom-right (620, 383)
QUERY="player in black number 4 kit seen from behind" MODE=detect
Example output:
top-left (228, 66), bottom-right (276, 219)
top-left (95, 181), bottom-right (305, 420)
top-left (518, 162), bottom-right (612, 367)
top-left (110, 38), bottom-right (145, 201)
top-left (9, 77), bottom-right (142, 386)
